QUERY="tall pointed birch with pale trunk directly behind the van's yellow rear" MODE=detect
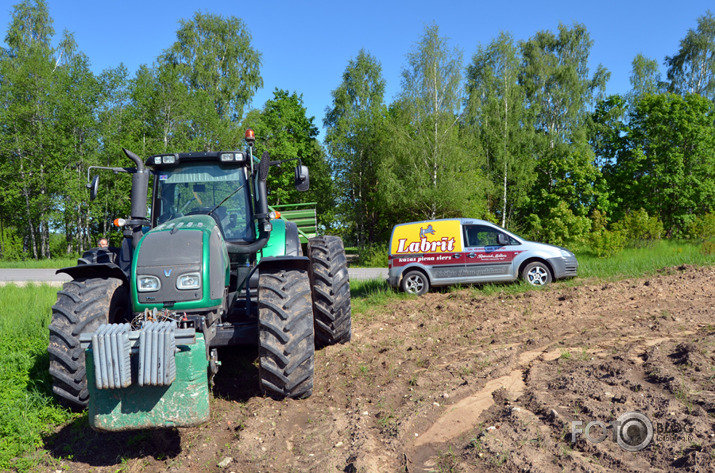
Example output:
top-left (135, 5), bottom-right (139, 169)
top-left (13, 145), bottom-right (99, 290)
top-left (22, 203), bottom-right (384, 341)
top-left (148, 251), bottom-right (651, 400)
top-left (379, 26), bottom-right (485, 221)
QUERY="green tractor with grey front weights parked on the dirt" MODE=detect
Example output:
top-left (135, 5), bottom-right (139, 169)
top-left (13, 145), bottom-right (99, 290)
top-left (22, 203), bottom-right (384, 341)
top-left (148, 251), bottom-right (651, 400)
top-left (48, 130), bottom-right (352, 431)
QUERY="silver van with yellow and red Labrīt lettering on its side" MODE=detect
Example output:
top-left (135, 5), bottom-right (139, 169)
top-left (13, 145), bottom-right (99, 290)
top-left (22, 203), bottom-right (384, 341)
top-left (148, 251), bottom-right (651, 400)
top-left (387, 218), bottom-right (578, 295)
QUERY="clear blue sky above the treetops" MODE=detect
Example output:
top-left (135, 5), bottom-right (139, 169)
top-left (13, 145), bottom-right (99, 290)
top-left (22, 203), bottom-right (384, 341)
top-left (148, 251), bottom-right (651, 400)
top-left (0, 0), bottom-right (715, 136)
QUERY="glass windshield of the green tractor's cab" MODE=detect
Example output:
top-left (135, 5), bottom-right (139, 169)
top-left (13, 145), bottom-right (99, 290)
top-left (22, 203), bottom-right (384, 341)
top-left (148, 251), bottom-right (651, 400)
top-left (155, 165), bottom-right (255, 241)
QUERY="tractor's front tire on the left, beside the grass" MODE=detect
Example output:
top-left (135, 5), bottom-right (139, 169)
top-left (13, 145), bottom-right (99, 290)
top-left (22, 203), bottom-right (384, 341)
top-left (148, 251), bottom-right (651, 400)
top-left (47, 278), bottom-right (129, 412)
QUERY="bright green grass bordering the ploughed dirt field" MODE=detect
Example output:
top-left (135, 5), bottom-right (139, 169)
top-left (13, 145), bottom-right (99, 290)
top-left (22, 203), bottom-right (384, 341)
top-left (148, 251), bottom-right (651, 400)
top-left (0, 242), bottom-right (715, 471)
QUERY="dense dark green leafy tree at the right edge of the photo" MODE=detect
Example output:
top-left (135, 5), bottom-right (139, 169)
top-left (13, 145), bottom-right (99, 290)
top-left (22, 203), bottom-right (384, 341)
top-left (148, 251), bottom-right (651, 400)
top-left (609, 93), bottom-right (715, 236)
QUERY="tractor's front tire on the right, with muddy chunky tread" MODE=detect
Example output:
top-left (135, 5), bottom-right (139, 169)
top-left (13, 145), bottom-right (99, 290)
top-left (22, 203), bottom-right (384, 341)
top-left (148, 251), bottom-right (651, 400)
top-left (258, 268), bottom-right (315, 399)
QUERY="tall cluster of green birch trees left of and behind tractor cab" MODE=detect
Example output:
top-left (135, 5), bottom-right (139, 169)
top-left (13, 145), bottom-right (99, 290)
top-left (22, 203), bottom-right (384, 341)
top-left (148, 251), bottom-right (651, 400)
top-left (0, 4), bottom-right (268, 258)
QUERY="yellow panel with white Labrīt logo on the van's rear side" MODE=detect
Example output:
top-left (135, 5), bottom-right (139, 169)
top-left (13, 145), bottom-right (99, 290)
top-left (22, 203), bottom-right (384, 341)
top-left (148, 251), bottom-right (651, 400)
top-left (390, 220), bottom-right (462, 255)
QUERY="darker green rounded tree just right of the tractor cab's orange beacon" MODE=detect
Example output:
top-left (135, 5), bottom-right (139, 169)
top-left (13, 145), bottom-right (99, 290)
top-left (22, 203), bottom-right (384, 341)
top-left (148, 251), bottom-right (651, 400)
top-left (244, 89), bottom-right (334, 225)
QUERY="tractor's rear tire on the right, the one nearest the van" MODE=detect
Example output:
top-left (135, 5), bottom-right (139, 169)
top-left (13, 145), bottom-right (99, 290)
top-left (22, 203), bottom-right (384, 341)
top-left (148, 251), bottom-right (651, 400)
top-left (308, 236), bottom-right (352, 347)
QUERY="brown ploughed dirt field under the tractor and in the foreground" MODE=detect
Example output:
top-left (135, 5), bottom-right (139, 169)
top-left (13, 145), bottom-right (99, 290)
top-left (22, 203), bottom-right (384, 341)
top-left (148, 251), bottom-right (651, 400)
top-left (47, 267), bottom-right (715, 473)
